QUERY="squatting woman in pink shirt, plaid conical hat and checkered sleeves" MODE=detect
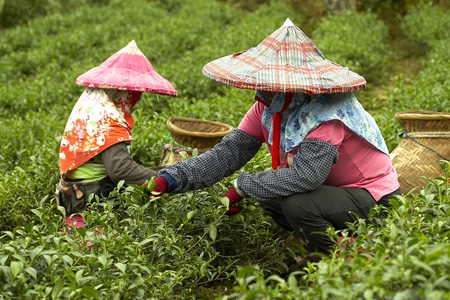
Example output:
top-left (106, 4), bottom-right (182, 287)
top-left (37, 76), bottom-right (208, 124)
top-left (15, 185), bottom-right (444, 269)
top-left (151, 19), bottom-right (401, 262)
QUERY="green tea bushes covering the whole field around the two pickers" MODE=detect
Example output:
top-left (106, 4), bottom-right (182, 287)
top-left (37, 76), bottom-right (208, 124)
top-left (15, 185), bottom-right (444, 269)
top-left (0, 0), bottom-right (450, 299)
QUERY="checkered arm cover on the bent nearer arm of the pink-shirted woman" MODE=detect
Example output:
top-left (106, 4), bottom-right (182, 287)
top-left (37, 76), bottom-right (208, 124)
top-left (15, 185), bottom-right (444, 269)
top-left (237, 139), bottom-right (338, 201)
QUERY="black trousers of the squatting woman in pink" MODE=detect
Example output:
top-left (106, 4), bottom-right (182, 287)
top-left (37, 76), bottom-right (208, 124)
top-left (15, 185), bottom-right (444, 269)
top-left (260, 185), bottom-right (401, 253)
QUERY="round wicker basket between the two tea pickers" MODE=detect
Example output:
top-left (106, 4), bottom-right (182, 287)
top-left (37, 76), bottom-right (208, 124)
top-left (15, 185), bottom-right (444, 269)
top-left (167, 118), bottom-right (233, 149)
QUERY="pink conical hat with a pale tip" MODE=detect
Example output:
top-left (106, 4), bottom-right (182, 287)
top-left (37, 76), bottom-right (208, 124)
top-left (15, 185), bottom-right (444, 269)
top-left (75, 41), bottom-right (178, 96)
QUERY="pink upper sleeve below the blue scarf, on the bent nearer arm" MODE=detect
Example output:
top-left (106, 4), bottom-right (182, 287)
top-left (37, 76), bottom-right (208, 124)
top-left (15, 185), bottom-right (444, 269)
top-left (305, 120), bottom-right (348, 149)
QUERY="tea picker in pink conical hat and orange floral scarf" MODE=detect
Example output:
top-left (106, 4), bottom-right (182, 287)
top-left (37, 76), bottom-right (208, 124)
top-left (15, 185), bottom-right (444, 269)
top-left (56, 41), bottom-right (177, 225)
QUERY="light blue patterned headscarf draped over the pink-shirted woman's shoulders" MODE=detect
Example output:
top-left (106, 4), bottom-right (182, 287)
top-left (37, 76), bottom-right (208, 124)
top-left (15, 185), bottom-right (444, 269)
top-left (256, 91), bottom-right (389, 154)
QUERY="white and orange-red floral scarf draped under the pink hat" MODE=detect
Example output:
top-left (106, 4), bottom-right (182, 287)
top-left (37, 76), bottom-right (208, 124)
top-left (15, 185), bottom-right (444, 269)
top-left (59, 88), bottom-right (142, 173)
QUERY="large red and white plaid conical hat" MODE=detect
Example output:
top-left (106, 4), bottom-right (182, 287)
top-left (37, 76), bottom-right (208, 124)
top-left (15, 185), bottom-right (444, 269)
top-left (203, 18), bottom-right (366, 94)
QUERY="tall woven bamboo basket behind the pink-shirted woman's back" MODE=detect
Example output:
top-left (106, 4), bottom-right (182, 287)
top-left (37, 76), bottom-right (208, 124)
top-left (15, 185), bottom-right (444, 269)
top-left (391, 111), bottom-right (450, 194)
